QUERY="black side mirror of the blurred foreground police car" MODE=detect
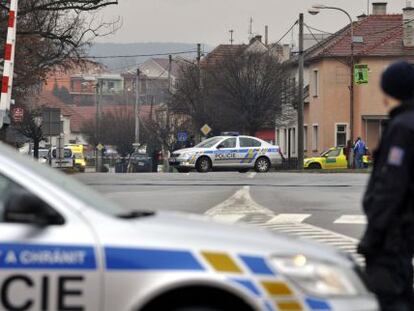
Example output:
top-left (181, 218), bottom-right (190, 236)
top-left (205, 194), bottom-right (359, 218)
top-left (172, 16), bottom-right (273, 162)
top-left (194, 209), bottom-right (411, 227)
top-left (4, 191), bottom-right (65, 227)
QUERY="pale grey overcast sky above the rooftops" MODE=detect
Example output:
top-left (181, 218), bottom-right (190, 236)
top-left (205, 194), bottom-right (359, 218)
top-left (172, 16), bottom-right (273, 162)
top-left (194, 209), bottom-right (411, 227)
top-left (101, 0), bottom-right (408, 45)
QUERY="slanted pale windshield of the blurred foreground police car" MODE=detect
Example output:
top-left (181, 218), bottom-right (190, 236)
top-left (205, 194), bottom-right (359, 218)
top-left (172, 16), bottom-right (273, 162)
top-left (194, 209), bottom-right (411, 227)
top-left (0, 143), bottom-right (126, 217)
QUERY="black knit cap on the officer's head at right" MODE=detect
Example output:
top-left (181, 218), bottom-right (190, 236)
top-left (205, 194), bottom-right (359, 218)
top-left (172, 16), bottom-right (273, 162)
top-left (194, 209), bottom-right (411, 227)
top-left (381, 61), bottom-right (414, 101)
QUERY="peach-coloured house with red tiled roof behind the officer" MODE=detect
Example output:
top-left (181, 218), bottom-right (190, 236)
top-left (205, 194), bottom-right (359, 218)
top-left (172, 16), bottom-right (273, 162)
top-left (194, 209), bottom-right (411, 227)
top-left (276, 2), bottom-right (414, 156)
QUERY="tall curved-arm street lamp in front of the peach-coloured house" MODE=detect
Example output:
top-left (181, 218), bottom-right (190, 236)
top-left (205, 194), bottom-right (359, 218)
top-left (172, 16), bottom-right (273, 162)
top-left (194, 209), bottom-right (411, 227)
top-left (308, 4), bottom-right (355, 155)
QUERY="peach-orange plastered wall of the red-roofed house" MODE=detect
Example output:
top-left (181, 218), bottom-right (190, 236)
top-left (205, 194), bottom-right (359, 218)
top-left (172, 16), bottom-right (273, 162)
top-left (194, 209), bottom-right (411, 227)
top-left (305, 58), bottom-right (402, 155)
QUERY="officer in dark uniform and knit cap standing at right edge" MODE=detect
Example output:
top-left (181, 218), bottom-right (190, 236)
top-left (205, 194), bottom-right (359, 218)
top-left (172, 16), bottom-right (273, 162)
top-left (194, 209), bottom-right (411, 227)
top-left (358, 62), bottom-right (414, 311)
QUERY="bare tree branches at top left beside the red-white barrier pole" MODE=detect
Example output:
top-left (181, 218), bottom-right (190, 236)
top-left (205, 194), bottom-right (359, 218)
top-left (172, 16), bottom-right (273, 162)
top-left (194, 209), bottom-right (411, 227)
top-left (0, 0), bottom-right (119, 98)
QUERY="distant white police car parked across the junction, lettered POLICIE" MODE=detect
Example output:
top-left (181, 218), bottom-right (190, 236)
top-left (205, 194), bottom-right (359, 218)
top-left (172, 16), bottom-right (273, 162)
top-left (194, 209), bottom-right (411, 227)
top-left (169, 136), bottom-right (282, 173)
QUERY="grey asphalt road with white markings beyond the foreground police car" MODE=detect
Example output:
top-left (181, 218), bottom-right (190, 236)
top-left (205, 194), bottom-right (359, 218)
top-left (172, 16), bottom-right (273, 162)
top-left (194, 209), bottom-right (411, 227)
top-left (76, 172), bottom-right (369, 246)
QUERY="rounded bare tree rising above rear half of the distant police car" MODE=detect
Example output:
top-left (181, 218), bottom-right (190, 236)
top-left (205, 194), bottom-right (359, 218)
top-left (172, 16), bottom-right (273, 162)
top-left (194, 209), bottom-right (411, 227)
top-left (210, 50), bottom-right (287, 135)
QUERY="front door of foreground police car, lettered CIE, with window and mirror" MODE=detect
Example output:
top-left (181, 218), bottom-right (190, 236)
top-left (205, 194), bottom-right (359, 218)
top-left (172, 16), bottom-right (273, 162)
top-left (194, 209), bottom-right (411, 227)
top-left (0, 172), bottom-right (103, 311)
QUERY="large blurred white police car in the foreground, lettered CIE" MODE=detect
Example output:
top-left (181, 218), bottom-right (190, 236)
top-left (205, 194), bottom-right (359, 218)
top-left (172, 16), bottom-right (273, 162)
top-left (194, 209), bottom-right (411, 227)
top-left (0, 144), bottom-right (377, 311)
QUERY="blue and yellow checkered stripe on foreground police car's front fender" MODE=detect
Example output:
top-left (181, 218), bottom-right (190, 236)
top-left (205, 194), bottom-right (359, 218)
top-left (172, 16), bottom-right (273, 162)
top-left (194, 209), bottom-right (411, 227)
top-left (105, 247), bottom-right (331, 311)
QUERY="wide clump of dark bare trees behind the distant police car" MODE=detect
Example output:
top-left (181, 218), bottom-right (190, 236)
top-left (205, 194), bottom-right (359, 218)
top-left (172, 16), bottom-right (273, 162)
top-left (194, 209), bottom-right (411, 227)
top-left (172, 48), bottom-right (295, 135)
